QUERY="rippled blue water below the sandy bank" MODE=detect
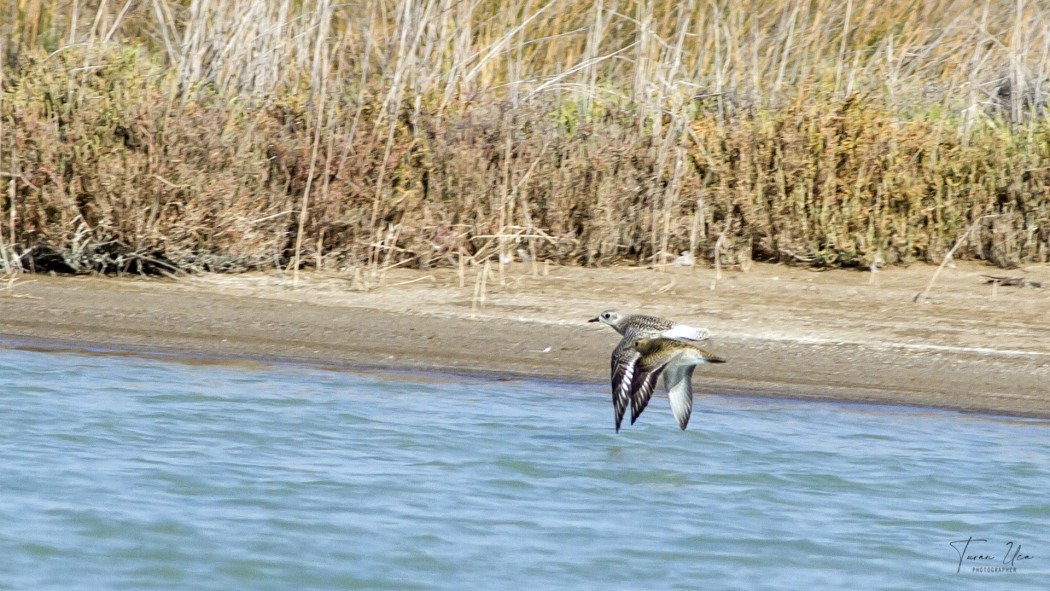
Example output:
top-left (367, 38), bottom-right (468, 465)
top-left (0, 350), bottom-right (1050, 590)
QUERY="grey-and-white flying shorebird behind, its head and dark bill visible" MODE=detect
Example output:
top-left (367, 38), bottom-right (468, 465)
top-left (588, 310), bottom-right (711, 432)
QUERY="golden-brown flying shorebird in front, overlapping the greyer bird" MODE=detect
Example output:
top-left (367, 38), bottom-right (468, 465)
top-left (631, 337), bottom-right (726, 430)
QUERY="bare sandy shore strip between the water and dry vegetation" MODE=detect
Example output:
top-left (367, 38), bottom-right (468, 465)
top-left (0, 263), bottom-right (1050, 418)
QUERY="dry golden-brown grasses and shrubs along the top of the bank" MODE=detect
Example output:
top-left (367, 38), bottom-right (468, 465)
top-left (0, 0), bottom-right (1050, 273)
